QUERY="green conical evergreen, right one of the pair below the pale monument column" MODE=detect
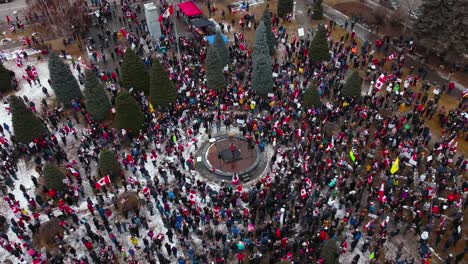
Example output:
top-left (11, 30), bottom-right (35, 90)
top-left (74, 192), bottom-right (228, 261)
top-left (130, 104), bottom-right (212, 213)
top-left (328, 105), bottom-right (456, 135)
top-left (150, 60), bottom-right (177, 107)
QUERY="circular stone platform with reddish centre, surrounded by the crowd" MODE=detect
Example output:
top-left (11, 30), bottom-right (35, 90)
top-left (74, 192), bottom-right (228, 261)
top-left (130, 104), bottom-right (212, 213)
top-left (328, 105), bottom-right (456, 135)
top-left (197, 135), bottom-right (266, 182)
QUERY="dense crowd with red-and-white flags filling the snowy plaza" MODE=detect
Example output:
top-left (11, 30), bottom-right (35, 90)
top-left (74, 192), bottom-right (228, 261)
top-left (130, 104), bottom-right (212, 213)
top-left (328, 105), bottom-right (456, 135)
top-left (0, 1), bottom-right (468, 264)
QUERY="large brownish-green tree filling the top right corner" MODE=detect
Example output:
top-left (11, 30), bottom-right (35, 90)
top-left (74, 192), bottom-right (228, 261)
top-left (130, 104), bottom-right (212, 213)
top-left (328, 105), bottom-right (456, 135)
top-left (413, 0), bottom-right (468, 60)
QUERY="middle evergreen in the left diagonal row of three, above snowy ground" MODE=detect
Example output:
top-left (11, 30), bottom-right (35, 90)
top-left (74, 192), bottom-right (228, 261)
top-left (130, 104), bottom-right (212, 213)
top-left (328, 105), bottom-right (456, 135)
top-left (84, 70), bottom-right (111, 121)
